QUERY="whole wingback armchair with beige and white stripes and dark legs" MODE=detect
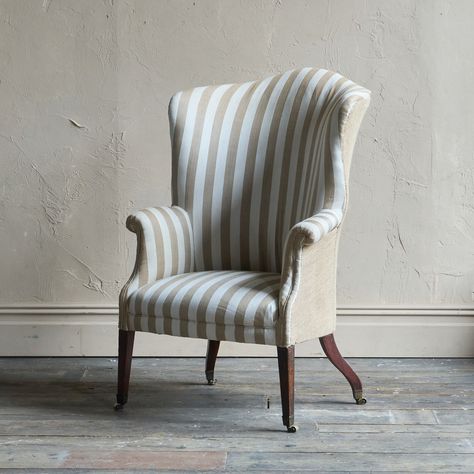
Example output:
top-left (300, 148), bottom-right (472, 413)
top-left (116, 68), bottom-right (370, 432)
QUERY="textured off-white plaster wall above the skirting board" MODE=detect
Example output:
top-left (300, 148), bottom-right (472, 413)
top-left (0, 0), bottom-right (474, 306)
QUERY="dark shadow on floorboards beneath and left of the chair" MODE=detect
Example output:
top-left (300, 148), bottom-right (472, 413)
top-left (0, 361), bottom-right (353, 429)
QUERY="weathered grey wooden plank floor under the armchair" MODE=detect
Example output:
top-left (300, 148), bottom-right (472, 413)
top-left (0, 358), bottom-right (474, 473)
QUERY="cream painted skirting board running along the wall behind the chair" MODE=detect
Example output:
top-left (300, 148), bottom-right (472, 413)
top-left (0, 305), bottom-right (474, 357)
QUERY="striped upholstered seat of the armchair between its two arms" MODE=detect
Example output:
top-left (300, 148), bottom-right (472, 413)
top-left (128, 271), bottom-right (280, 344)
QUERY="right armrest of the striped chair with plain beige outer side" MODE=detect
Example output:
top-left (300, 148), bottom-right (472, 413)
top-left (277, 209), bottom-right (342, 346)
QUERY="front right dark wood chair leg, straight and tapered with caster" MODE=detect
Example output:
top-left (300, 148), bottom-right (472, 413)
top-left (277, 346), bottom-right (297, 433)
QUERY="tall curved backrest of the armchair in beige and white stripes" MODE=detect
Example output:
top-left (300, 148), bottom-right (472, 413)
top-left (169, 68), bottom-right (367, 272)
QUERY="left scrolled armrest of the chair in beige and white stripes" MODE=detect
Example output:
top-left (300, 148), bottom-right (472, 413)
top-left (120, 206), bottom-right (194, 305)
